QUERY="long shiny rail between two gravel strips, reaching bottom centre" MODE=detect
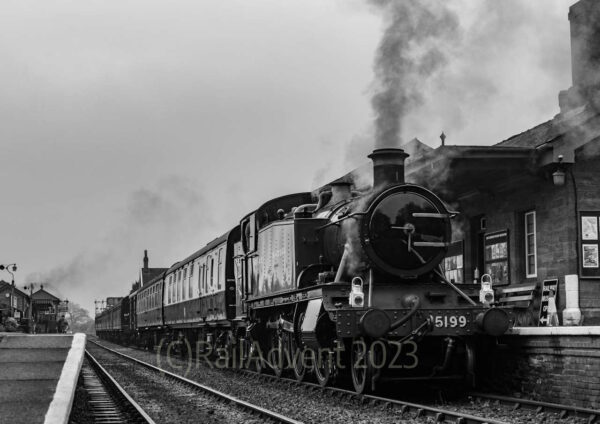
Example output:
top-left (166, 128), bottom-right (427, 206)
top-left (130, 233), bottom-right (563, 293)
top-left (88, 340), bottom-right (302, 424)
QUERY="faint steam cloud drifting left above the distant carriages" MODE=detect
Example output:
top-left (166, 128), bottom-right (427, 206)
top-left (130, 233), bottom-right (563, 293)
top-left (27, 176), bottom-right (216, 312)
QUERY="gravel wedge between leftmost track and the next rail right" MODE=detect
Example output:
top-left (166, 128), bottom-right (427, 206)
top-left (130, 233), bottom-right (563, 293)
top-left (87, 344), bottom-right (262, 424)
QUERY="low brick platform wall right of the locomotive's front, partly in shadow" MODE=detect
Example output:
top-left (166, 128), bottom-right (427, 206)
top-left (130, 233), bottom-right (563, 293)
top-left (480, 336), bottom-right (600, 409)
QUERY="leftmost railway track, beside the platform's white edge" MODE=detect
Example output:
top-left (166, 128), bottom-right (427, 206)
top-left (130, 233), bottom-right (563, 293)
top-left (81, 350), bottom-right (154, 424)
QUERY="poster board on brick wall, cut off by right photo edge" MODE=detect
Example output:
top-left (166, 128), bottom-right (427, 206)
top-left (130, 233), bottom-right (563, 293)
top-left (579, 212), bottom-right (600, 278)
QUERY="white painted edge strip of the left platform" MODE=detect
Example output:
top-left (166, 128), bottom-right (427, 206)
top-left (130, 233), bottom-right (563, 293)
top-left (44, 333), bottom-right (85, 424)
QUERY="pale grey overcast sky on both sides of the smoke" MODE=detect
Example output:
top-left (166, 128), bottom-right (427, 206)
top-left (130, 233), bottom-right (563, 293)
top-left (0, 0), bottom-right (575, 309)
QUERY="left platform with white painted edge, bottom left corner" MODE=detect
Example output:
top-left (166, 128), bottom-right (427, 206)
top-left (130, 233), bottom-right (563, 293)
top-left (0, 333), bottom-right (86, 424)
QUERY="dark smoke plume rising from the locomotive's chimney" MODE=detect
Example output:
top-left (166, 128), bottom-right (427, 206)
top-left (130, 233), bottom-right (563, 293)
top-left (370, 0), bottom-right (460, 148)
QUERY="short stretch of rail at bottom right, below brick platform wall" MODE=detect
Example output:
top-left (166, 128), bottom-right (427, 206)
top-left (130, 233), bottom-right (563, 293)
top-left (468, 392), bottom-right (600, 424)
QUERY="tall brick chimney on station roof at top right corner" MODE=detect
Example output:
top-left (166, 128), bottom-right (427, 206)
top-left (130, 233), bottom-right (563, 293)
top-left (560, 0), bottom-right (600, 110)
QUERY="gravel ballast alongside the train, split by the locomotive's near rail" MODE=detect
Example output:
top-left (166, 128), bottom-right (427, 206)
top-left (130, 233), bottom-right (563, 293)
top-left (88, 341), bottom-right (587, 424)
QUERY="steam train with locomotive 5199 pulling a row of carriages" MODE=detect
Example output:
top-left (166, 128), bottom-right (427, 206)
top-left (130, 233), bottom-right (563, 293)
top-left (96, 149), bottom-right (511, 393)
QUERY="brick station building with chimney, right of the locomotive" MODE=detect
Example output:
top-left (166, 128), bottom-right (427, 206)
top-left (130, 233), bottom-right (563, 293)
top-left (406, 0), bottom-right (600, 326)
